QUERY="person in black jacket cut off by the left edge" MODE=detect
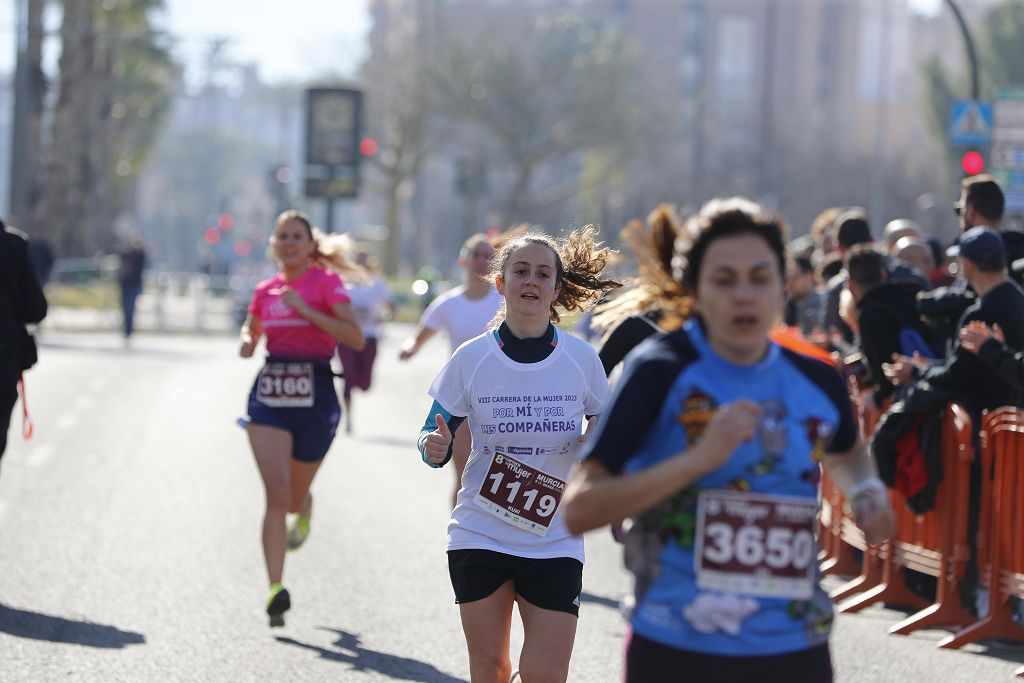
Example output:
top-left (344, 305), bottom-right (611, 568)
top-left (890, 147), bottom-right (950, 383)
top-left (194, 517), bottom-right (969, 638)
top-left (0, 221), bottom-right (46, 464)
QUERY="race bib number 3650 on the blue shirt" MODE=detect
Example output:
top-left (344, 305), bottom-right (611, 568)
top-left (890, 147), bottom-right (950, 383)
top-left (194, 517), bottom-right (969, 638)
top-left (694, 490), bottom-right (817, 599)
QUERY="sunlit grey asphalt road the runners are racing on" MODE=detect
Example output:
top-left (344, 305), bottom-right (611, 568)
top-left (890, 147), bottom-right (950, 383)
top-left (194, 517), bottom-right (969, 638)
top-left (0, 328), bottom-right (1024, 683)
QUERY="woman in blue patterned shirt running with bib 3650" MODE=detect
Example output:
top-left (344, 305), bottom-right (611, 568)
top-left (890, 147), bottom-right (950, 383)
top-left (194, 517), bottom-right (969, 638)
top-left (563, 199), bottom-right (892, 683)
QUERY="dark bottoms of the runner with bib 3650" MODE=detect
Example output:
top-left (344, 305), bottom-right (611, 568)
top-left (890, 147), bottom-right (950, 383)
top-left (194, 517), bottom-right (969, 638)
top-left (626, 634), bottom-right (833, 683)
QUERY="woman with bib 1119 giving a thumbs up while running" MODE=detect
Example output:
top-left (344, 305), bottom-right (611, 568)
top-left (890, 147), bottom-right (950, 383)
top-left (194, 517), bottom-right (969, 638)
top-left (419, 228), bottom-right (618, 683)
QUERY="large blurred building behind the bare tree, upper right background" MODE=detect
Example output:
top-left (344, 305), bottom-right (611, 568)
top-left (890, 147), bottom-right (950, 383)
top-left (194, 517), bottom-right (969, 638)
top-left (368, 0), bottom-right (996, 266)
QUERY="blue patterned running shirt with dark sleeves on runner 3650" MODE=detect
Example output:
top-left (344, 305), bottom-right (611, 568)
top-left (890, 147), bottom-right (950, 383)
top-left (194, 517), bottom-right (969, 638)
top-left (583, 321), bottom-right (858, 656)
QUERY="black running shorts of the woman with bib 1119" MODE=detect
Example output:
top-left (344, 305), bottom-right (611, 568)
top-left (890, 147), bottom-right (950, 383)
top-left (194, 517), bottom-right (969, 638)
top-left (449, 550), bottom-right (583, 616)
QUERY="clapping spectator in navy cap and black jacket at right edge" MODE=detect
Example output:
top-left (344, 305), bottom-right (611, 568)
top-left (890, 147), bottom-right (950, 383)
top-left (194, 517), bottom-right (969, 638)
top-left (884, 226), bottom-right (1024, 415)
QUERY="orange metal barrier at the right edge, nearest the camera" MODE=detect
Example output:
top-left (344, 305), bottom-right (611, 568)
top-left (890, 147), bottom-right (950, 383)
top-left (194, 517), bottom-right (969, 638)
top-left (939, 408), bottom-right (1024, 663)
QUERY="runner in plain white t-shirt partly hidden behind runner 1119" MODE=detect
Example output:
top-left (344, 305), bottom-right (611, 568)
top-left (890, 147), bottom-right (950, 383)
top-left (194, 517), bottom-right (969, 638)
top-left (398, 232), bottom-right (502, 507)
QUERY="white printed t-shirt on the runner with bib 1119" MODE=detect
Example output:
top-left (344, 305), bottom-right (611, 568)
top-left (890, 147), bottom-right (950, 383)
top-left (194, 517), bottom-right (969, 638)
top-left (429, 331), bottom-right (608, 562)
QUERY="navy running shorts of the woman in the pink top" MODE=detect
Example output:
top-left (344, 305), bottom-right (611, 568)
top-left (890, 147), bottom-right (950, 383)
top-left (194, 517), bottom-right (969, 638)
top-left (248, 359), bottom-right (341, 463)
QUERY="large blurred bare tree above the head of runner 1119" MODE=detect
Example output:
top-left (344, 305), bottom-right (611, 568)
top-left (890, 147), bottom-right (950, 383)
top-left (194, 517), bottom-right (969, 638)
top-left (432, 13), bottom-right (653, 222)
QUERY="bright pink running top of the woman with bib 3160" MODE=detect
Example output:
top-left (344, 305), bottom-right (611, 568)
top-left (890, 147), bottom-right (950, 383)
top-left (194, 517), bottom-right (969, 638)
top-left (249, 266), bottom-right (351, 360)
